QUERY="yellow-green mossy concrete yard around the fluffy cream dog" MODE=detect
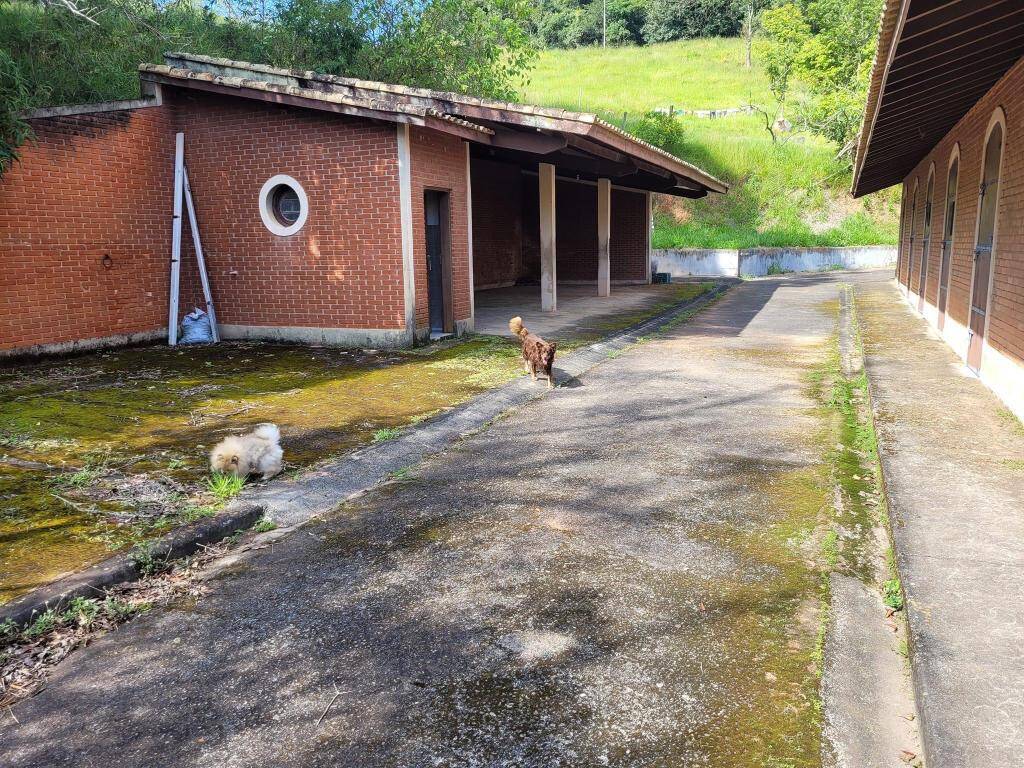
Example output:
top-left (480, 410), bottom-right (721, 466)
top-left (0, 336), bottom-right (521, 602)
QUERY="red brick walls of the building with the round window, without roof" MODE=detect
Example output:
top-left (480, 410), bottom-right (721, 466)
top-left (0, 86), bottom-right (647, 354)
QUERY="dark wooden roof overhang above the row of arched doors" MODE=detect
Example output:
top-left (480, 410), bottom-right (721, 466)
top-left (853, 0), bottom-right (1024, 197)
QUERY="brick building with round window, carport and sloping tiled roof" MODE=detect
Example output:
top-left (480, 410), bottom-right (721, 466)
top-left (0, 54), bottom-right (726, 355)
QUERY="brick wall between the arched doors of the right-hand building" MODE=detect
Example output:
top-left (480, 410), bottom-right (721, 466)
top-left (900, 55), bottom-right (1024, 361)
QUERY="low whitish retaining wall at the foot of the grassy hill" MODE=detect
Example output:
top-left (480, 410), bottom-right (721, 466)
top-left (651, 246), bottom-right (896, 278)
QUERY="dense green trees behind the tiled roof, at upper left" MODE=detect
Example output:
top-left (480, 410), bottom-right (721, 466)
top-left (0, 0), bottom-right (536, 172)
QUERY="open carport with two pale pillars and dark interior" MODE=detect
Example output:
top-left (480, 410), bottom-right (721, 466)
top-left (451, 104), bottom-right (728, 312)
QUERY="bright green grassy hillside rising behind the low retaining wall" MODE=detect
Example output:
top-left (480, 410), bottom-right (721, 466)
top-left (522, 39), bottom-right (898, 248)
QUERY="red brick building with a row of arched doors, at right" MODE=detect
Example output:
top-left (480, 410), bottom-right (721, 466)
top-left (853, 0), bottom-right (1024, 418)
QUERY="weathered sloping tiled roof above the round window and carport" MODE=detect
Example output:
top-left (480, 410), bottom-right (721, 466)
top-left (139, 53), bottom-right (728, 198)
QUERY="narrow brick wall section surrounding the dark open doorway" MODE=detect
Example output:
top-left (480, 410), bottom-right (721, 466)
top-left (409, 126), bottom-right (471, 330)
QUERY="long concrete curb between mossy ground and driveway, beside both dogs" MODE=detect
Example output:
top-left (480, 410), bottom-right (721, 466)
top-left (0, 280), bottom-right (738, 626)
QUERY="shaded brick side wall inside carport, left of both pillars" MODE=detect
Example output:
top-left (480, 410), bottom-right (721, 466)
top-left (473, 160), bottom-right (520, 289)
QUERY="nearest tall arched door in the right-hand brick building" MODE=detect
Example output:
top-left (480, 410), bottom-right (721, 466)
top-left (967, 124), bottom-right (1002, 372)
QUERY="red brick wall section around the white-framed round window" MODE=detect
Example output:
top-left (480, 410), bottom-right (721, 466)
top-left (178, 93), bottom-right (403, 329)
